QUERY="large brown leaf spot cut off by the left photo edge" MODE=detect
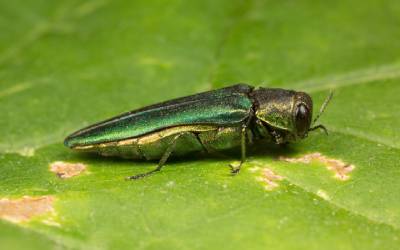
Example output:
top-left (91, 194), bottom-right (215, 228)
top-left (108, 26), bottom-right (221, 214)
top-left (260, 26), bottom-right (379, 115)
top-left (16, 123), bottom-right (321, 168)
top-left (0, 196), bottom-right (54, 223)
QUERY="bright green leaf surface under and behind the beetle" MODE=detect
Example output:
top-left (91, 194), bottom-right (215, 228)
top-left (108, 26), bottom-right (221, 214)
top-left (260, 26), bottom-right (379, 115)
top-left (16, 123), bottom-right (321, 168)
top-left (0, 0), bottom-right (400, 249)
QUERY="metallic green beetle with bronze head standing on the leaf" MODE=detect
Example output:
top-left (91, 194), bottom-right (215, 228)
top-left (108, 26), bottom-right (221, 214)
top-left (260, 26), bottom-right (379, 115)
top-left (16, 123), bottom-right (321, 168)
top-left (64, 84), bottom-right (332, 179)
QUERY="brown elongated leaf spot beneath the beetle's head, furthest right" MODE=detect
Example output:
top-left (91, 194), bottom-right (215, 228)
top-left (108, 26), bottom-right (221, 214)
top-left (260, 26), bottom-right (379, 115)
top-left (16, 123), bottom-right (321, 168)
top-left (279, 153), bottom-right (355, 181)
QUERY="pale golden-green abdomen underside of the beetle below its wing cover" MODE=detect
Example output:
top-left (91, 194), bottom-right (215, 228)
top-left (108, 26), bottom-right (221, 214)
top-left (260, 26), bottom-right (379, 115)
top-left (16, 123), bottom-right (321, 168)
top-left (74, 126), bottom-right (247, 160)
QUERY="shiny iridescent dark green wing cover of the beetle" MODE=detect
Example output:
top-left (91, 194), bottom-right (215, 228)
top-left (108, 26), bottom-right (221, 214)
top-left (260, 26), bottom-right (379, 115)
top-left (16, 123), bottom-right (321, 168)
top-left (65, 84), bottom-right (253, 147)
